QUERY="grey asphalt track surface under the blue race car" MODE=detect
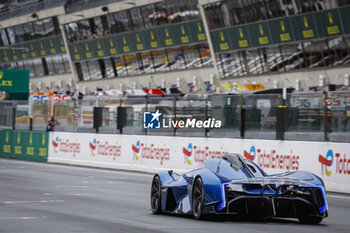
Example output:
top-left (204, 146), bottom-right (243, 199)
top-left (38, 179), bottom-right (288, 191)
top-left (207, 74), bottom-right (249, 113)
top-left (0, 159), bottom-right (350, 233)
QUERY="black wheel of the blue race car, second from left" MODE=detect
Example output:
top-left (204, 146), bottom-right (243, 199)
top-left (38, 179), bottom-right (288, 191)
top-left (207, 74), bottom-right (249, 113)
top-left (192, 178), bottom-right (204, 219)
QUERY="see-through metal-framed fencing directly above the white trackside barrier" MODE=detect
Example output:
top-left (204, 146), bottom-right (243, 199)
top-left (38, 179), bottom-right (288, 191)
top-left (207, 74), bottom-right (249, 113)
top-left (0, 92), bottom-right (350, 142)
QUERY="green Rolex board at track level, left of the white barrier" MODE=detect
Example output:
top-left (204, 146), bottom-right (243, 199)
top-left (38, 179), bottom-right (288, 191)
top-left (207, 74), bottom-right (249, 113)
top-left (0, 130), bottom-right (48, 162)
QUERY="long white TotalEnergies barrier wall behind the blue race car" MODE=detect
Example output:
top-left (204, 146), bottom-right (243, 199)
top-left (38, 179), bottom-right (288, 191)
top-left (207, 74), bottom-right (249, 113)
top-left (48, 132), bottom-right (350, 193)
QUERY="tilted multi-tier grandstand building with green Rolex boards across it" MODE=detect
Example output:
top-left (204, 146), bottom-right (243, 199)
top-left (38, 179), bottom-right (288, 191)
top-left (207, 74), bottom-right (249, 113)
top-left (0, 0), bottom-right (350, 94)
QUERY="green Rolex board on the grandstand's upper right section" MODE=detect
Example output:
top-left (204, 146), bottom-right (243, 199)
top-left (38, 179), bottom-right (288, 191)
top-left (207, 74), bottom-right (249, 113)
top-left (210, 7), bottom-right (350, 53)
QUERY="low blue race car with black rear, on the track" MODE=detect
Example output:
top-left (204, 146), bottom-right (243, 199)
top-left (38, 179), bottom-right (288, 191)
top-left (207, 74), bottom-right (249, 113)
top-left (151, 154), bottom-right (328, 224)
